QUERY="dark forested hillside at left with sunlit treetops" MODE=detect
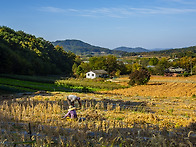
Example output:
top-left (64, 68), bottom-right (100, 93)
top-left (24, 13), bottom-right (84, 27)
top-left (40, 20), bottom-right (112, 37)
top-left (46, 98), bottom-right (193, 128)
top-left (0, 26), bottom-right (75, 75)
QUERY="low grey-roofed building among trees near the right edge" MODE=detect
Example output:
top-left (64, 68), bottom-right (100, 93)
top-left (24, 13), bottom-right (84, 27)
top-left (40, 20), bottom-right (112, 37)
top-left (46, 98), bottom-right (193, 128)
top-left (165, 67), bottom-right (185, 77)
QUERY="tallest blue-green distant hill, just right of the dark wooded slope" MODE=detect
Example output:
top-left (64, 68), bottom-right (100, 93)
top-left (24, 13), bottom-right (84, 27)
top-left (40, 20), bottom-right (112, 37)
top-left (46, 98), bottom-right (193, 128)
top-left (52, 40), bottom-right (125, 55)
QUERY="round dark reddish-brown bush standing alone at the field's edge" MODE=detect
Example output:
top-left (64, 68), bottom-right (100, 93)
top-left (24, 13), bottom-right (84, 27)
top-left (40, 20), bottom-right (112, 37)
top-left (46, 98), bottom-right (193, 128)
top-left (128, 68), bottom-right (150, 86)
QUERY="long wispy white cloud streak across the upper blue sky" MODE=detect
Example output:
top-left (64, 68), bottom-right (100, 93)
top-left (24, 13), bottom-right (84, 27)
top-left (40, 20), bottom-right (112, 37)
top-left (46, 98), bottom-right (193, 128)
top-left (40, 6), bottom-right (196, 18)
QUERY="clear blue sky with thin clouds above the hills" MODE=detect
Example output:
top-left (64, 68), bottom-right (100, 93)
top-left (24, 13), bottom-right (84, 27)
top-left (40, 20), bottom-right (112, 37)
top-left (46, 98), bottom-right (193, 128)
top-left (0, 0), bottom-right (196, 49)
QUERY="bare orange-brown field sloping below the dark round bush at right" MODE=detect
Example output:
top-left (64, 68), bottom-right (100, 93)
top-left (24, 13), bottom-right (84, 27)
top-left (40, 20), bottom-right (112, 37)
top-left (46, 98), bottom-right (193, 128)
top-left (103, 76), bottom-right (196, 97)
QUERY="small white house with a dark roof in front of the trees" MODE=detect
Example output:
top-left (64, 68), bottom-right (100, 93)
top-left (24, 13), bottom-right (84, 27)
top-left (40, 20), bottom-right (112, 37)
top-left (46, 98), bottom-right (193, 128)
top-left (86, 70), bottom-right (108, 79)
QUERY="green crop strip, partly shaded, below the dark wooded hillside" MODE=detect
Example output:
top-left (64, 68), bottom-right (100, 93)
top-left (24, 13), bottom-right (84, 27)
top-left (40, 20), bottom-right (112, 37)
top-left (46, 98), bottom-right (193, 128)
top-left (0, 75), bottom-right (127, 94)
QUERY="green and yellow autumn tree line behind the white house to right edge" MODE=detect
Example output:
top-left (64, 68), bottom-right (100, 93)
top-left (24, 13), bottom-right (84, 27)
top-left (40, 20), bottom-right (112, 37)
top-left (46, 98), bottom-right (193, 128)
top-left (72, 55), bottom-right (196, 77)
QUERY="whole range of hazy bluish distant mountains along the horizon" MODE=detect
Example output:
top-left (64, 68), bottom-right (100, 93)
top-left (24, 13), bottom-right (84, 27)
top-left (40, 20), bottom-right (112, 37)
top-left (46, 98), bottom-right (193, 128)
top-left (52, 40), bottom-right (196, 56)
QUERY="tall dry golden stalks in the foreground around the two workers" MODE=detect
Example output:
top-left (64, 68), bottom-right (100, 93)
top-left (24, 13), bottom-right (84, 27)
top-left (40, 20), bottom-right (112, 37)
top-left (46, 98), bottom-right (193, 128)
top-left (0, 96), bottom-right (195, 146)
